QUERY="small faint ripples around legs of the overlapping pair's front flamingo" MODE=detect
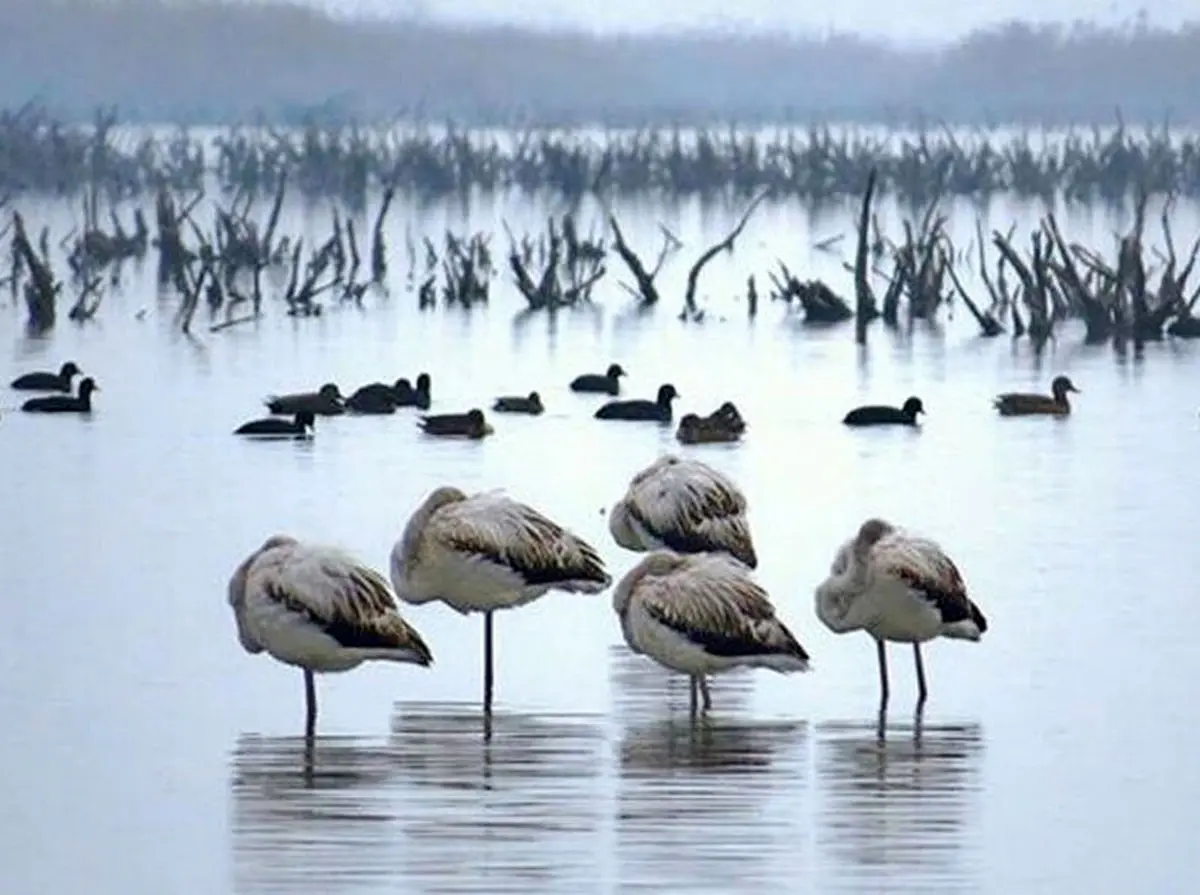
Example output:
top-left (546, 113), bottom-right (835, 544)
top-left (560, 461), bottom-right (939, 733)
top-left (608, 643), bottom-right (754, 725)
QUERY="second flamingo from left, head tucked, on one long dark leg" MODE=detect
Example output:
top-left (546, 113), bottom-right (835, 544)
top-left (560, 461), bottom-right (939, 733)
top-left (391, 486), bottom-right (612, 716)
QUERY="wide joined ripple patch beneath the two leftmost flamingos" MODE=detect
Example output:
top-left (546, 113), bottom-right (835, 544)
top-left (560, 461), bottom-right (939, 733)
top-left (233, 703), bottom-right (605, 893)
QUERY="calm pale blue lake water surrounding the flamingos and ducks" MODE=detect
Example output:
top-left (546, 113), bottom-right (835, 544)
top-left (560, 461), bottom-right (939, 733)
top-left (0, 184), bottom-right (1200, 895)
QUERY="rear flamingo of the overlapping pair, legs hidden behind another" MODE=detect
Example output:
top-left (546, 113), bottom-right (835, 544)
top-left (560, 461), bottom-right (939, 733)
top-left (608, 455), bottom-right (758, 569)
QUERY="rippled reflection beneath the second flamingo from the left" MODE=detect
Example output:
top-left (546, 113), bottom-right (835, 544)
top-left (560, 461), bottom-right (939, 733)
top-left (390, 703), bottom-right (607, 893)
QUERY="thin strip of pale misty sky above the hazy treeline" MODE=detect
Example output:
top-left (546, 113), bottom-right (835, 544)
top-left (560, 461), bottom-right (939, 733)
top-left (328, 0), bottom-right (1200, 42)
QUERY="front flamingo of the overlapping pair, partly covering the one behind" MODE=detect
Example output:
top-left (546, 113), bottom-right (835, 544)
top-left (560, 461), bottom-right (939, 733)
top-left (612, 551), bottom-right (809, 715)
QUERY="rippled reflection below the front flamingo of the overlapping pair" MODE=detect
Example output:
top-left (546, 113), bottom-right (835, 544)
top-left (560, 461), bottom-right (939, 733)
top-left (614, 705), bottom-right (806, 891)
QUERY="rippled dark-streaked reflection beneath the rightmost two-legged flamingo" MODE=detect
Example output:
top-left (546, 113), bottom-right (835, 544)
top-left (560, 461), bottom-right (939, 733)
top-left (816, 715), bottom-right (984, 891)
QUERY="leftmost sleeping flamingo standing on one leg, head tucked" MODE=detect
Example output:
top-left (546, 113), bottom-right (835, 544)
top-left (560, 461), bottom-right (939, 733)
top-left (229, 535), bottom-right (433, 738)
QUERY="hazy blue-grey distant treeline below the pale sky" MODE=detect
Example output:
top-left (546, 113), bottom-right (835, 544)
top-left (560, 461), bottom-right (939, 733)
top-left (7, 0), bottom-right (1200, 125)
